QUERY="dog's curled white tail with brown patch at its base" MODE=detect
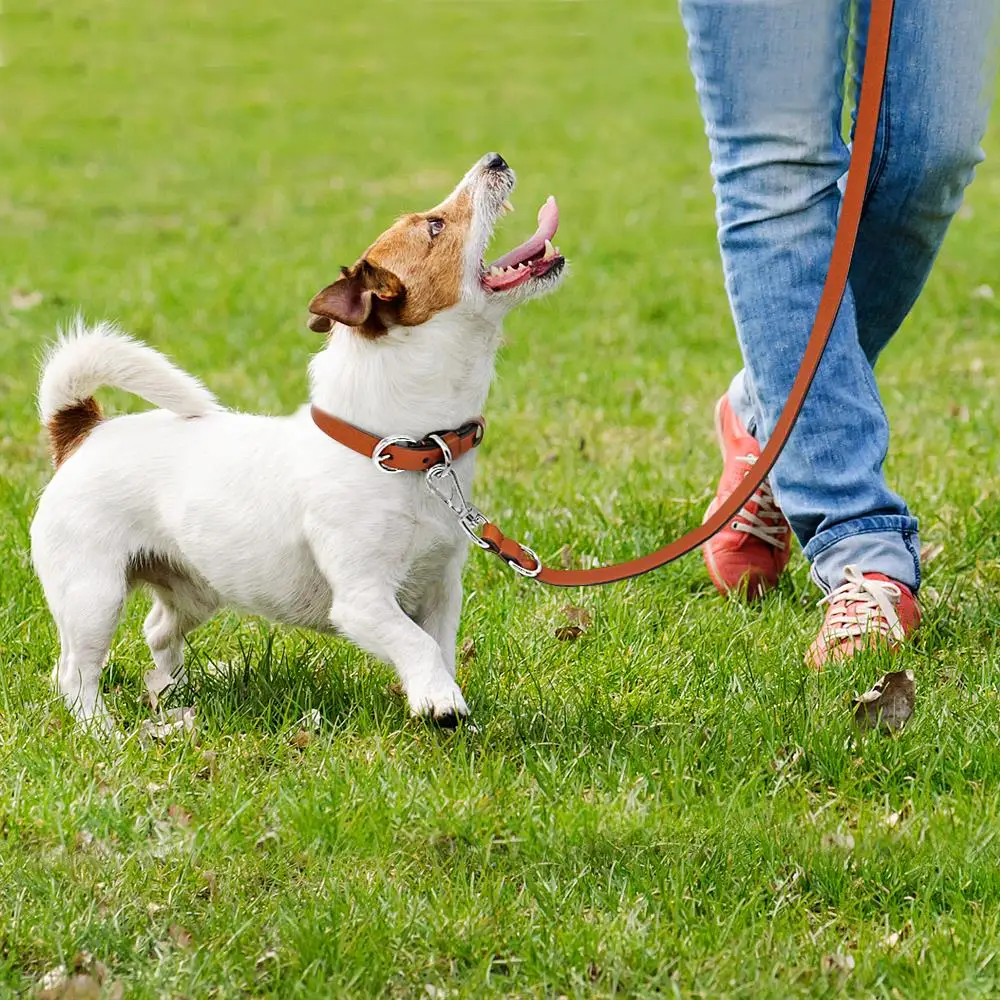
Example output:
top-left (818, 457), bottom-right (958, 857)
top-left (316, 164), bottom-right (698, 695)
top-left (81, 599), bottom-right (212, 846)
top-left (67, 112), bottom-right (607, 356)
top-left (38, 317), bottom-right (220, 466)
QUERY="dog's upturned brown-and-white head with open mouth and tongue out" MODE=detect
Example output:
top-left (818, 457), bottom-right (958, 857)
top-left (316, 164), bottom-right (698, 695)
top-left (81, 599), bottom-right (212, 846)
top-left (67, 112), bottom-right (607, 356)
top-left (309, 153), bottom-right (566, 337)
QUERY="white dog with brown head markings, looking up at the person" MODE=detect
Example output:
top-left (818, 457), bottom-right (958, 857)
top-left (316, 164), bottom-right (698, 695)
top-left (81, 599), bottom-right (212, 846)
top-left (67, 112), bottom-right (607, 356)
top-left (31, 153), bottom-right (565, 732)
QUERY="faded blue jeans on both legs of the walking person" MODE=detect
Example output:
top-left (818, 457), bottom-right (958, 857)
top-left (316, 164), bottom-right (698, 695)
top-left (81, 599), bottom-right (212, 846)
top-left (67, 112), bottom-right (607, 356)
top-left (681, 0), bottom-right (996, 591)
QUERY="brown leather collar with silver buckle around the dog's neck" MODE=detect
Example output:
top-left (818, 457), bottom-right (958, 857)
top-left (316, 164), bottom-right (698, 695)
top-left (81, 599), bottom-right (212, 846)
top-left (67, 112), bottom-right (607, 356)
top-left (309, 406), bottom-right (486, 472)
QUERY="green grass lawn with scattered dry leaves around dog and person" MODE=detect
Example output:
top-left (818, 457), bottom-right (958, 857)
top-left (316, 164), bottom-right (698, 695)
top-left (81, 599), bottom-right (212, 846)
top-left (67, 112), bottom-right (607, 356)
top-left (0, 0), bottom-right (1000, 998)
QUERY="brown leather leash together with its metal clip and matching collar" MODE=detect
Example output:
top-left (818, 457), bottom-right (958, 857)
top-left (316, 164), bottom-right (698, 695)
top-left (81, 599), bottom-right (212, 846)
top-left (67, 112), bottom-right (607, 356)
top-left (312, 0), bottom-right (893, 587)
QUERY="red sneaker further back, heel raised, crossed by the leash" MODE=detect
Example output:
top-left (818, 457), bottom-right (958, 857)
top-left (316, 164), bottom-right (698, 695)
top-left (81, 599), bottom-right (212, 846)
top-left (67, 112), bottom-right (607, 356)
top-left (702, 394), bottom-right (792, 601)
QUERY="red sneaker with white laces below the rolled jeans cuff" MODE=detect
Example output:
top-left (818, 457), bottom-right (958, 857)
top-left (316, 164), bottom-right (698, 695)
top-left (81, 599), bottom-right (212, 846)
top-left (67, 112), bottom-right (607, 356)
top-left (806, 566), bottom-right (920, 670)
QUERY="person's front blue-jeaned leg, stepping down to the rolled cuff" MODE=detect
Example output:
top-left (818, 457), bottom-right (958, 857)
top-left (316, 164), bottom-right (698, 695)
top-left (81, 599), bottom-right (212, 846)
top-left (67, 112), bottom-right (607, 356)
top-left (681, 0), bottom-right (919, 590)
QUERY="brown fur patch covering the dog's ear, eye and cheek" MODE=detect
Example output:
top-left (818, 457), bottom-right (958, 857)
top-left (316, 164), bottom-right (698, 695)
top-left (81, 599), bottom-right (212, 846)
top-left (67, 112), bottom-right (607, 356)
top-left (309, 190), bottom-right (473, 337)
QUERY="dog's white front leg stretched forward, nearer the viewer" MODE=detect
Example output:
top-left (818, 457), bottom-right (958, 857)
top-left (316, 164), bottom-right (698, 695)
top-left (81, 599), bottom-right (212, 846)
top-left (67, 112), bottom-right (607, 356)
top-left (330, 581), bottom-right (469, 726)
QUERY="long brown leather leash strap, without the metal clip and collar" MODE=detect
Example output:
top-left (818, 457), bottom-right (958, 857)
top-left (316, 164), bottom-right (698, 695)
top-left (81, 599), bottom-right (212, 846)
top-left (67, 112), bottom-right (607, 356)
top-left (473, 0), bottom-right (893, 587)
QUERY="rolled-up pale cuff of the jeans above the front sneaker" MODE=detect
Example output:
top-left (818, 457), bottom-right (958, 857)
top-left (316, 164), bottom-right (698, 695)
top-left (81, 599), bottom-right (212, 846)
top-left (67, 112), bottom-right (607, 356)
top-left (804, 514), bottom-right (920, 594)
